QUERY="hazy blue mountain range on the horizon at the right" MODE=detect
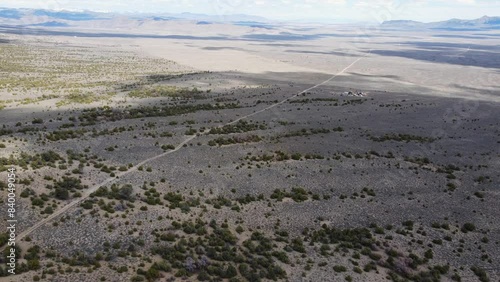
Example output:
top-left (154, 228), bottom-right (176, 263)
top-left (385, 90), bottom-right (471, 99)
top-left (382, 16), bottom-right (500, 30)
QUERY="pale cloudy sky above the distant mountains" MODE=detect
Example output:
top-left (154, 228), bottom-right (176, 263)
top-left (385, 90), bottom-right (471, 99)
top-left (0, 0), bottom-right (500, 22)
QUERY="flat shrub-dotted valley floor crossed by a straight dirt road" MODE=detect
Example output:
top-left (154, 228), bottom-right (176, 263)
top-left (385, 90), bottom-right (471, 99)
top-left (0, 25), bottom-right (500, 281)
